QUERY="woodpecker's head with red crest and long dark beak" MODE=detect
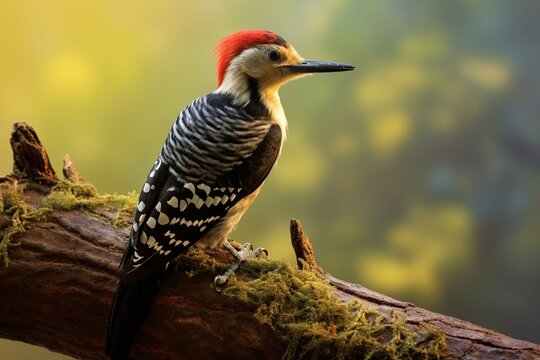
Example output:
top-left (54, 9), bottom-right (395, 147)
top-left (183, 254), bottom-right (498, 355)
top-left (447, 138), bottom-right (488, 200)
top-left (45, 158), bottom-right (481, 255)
top-left (216, 30), bottom-right (354, 97)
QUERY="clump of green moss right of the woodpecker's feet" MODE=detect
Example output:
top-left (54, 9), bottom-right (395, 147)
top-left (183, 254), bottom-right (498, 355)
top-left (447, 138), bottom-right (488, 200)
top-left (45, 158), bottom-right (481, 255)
top-left (224, 259), bottom-right (446, 359)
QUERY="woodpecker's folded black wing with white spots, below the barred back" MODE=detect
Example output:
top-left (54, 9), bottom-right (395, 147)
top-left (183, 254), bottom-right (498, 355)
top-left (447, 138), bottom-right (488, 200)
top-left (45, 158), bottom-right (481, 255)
top-left (121, 125), bottom-right (281, 282)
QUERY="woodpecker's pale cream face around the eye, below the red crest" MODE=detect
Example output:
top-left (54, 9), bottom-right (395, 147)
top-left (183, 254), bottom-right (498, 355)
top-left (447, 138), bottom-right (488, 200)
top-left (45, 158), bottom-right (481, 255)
top-left (231, 44), bottom-right (305, 88)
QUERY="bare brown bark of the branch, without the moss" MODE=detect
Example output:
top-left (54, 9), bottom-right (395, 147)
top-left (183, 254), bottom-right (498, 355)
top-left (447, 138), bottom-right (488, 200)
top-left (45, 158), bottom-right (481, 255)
top-left (0, 124), bottom-right (540, 359)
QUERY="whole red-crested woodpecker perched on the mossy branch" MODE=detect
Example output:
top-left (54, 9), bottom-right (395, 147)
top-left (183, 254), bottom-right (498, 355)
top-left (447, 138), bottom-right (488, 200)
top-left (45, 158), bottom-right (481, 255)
top-left (106, 30), bottom-right (354, 360)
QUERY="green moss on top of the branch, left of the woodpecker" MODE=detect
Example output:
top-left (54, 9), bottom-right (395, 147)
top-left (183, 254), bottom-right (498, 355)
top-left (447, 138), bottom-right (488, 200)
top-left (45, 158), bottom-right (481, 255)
top-left (0, 180), bottom-right (137, 266)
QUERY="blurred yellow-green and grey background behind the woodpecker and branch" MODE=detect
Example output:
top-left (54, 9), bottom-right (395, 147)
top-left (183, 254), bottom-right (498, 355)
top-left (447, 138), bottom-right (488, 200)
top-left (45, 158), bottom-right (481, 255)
top-left (0, 0), bottom-right (540, 359)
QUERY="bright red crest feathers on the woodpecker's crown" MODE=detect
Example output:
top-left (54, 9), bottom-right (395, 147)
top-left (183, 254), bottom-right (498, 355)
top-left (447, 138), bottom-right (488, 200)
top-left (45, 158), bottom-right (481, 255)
top-left (215, 30), bottom-right (286, 86)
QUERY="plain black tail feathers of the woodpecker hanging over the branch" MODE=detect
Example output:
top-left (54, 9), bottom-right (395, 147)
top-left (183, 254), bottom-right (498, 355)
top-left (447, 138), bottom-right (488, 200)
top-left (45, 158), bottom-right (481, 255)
top-left (105, 271), bottom-right (164, 360)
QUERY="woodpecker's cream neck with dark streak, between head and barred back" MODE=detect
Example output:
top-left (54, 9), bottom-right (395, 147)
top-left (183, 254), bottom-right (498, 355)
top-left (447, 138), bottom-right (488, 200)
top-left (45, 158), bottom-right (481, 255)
top-left (215, 67), bottom-right (287, 138)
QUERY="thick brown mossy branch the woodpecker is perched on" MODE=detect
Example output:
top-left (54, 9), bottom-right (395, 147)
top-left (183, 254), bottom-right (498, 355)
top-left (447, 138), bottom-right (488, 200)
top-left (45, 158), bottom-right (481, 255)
top-left (0, 124), bottom-right (540, 359)
